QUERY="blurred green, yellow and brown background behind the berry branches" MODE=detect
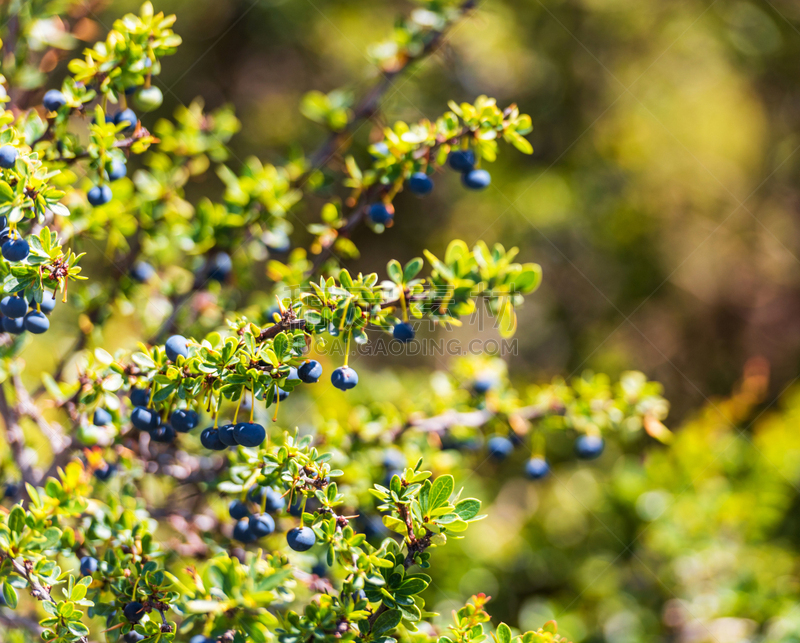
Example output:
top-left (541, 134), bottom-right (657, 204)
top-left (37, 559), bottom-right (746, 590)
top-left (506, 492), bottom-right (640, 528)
top-left (26, 0), bottom-right (800, 643)
